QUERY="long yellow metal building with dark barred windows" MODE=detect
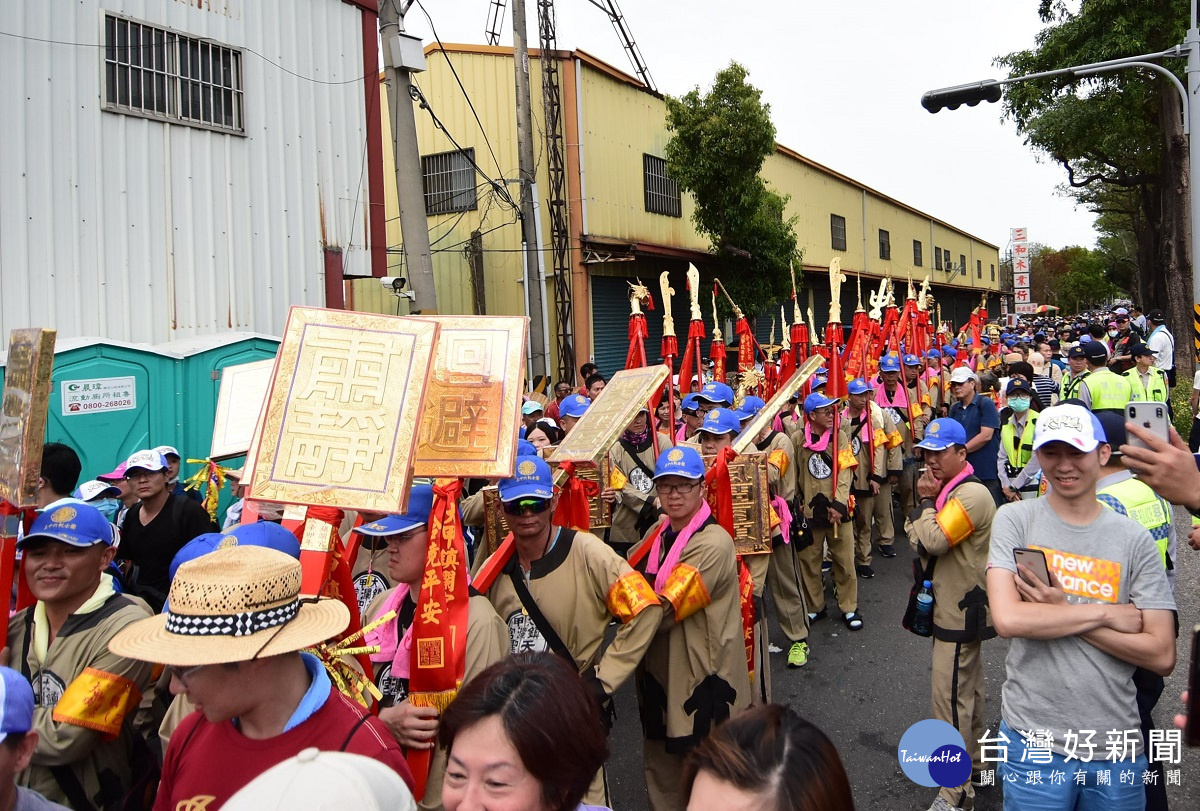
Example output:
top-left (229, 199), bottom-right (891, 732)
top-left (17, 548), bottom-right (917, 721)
top-left (347, 44), bottom-right (1000, 381)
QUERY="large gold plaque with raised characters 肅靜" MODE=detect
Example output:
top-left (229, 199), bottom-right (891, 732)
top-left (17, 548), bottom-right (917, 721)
top-left (247, 307), bottom-right (438, 512)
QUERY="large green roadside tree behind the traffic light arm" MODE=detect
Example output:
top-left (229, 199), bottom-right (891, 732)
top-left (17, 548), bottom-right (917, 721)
top-left (997, 0), bottom-right (1192, 379)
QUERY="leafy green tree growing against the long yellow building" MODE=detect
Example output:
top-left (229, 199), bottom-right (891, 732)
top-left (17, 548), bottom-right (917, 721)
top-left (666, 62), bottom-right (799, 313)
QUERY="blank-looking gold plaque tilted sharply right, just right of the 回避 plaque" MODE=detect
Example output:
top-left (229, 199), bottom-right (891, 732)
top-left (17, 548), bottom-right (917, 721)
top-left (547, 365), bottom-right (671, 465)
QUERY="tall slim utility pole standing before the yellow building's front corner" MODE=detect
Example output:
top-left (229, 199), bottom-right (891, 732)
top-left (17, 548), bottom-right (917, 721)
top-left (512, 0), bottom-right (549, 383)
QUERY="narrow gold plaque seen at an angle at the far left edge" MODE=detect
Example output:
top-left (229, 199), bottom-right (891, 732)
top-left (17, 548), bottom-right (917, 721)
top-left (0, 329), bottom-right (56, 507)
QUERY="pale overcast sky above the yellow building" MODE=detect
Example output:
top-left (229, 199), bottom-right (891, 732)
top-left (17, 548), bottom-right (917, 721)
top-left (406, 0), bottom-right (1096, 250)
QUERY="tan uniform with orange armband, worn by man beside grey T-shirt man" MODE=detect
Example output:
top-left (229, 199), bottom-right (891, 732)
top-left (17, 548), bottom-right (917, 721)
top-left (905, 434), bottom-right (996, 809)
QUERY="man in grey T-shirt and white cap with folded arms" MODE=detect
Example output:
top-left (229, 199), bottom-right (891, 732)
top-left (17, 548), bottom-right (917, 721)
top-left (988, 403), bottom-right (1175, 811)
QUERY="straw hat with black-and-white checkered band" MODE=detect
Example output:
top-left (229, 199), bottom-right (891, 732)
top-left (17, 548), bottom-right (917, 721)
top-left (108, 546), bottom-right (350, 667)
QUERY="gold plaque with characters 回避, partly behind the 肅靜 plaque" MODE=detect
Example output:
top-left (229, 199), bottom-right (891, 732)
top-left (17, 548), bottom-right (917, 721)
top-left (415, 316), bottom-right (529, 479)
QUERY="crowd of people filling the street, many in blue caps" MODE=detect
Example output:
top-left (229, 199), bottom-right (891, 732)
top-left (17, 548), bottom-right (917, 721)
top-left (0, 301), bottom-right (1200, 811)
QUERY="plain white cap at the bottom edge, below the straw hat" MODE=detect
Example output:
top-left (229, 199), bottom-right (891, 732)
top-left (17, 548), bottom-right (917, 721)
top-left (222, 749), bottom-right (416, 811)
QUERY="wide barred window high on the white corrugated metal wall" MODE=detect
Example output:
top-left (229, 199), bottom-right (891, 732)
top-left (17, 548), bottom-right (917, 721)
top-left (104, 14), bottom-right (245, 132)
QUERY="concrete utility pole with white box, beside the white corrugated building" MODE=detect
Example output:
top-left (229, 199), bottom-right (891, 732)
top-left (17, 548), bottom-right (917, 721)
top-left (379, 0), bottom-right (438, 316)
